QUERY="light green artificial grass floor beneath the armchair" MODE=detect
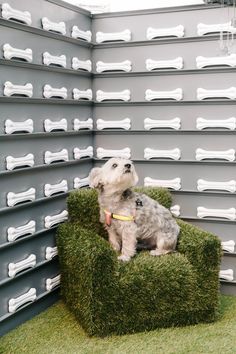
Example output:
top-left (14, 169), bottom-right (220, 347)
top-left (0, 296), bottom-right (236, 354)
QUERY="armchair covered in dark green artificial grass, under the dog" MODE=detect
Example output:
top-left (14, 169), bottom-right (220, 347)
top-left (57, 188), bottom-right (221, 336)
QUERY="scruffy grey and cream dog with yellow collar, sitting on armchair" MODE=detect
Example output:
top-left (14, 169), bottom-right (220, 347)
top-left (89, 158), bottom-right (179, 261)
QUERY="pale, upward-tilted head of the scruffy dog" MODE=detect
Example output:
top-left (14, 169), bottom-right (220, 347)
top-left (89, 157), bottom-right (138, 194)
